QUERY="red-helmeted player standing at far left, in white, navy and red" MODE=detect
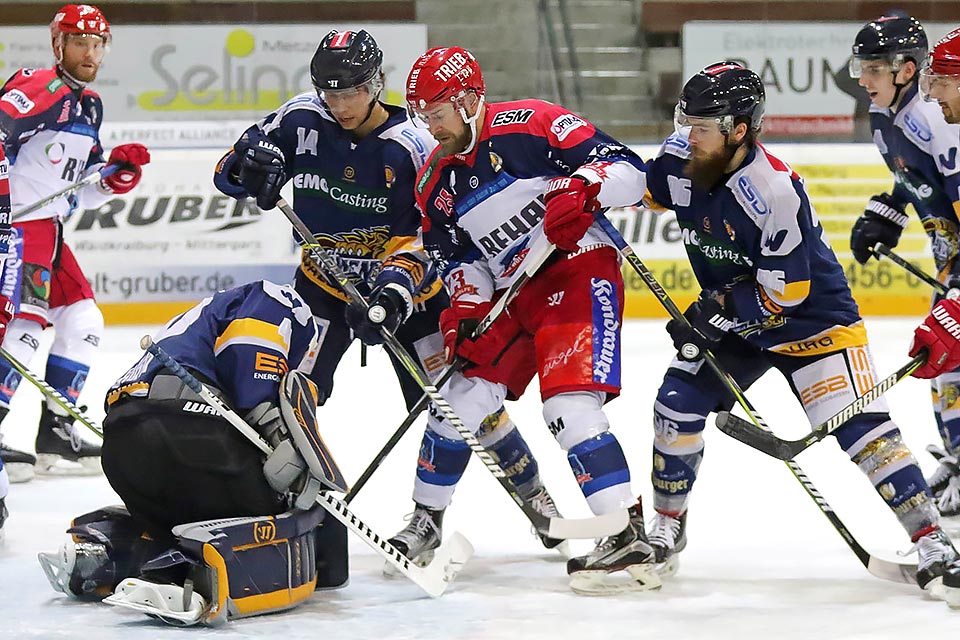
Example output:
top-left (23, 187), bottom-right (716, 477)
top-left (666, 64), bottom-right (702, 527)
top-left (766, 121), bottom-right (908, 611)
top-left (0, 4), bottom-right (150, 481)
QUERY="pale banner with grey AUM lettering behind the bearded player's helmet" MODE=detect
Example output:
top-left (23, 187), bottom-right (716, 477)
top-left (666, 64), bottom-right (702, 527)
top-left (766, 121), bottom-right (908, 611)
top-left (683, 21), bottom-right (956, 140)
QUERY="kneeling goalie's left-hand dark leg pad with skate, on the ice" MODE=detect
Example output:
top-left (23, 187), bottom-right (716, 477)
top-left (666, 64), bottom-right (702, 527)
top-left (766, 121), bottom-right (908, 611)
top-left (37, 506), bottom-right (164, 600)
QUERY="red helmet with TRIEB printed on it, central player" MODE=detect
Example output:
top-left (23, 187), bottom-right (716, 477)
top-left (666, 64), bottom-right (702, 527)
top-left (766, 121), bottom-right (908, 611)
top-left (407, 47), bottom-right (485, 111)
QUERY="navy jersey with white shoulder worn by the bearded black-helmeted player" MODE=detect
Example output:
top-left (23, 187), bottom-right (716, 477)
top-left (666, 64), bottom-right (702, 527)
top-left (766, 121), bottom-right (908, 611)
top-left (645, 134), bottom-right (867, 355)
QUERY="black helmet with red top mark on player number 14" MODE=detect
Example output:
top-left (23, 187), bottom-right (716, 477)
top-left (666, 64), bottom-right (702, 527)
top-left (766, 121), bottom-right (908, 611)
top-left (310, 29), bottom-right (383, 95)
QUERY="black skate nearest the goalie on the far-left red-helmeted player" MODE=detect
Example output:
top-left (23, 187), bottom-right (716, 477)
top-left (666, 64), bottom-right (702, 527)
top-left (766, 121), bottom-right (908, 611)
top-left (36, 402), bottom-right (103, 476)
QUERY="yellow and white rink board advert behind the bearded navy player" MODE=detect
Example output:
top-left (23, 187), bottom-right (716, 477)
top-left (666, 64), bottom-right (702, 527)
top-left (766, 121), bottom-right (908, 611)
top-left (620, 144), bottom-right (934, 318)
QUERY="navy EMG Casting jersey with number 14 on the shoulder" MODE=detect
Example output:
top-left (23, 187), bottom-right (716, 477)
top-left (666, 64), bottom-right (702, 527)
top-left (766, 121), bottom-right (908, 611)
top-left (214, 92), bottom-right (441, 300)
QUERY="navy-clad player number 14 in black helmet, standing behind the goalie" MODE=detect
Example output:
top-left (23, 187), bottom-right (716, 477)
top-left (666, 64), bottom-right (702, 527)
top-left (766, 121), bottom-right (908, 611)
top-left (214, 30), bottom-right (559, 562)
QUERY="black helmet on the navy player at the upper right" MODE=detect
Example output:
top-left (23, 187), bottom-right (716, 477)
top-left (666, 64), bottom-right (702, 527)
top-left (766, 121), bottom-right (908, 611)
top-left (850, 11), bottom-right (929, 78)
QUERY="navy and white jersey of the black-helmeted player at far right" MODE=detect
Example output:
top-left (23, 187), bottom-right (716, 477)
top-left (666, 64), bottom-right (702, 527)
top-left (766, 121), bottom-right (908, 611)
top-left (870, 84), bottom-right (960, 279)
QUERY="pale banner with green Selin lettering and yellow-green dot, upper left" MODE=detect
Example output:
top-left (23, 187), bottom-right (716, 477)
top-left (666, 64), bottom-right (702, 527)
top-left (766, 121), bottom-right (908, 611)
top-left (0, 23), bottom-right (427, 122)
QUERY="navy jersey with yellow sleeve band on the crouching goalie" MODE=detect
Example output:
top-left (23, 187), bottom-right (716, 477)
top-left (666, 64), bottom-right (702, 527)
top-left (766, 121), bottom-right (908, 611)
top-left (107, 280), bottom-right (318, 412)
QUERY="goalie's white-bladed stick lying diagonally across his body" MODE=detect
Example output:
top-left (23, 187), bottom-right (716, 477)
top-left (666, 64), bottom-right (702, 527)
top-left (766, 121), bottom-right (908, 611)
top-left (140, 336), bottom-right (473, 598)
